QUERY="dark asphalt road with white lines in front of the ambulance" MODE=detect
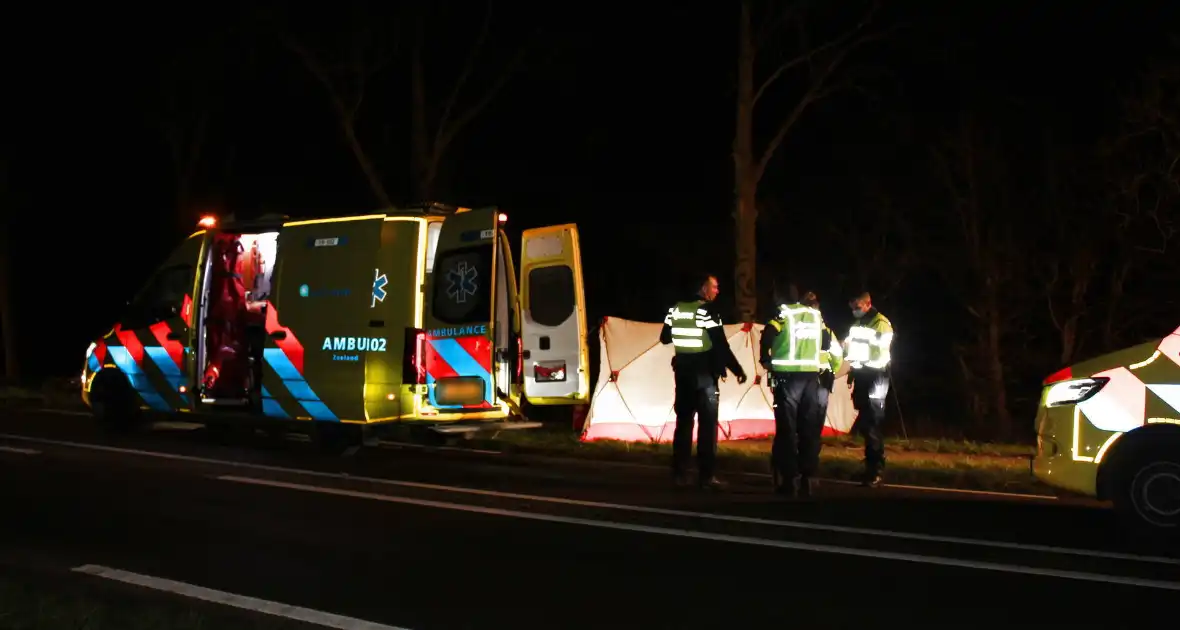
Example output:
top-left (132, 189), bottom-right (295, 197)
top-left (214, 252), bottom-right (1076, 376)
top-left (0, 413), bottom-right (1180, 630)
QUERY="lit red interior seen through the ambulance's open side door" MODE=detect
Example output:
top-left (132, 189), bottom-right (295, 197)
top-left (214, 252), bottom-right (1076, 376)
top-left (197, 231), bottom-right (278, 405)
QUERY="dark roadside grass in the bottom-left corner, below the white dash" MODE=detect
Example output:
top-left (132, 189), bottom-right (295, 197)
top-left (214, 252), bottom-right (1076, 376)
top-left (0, 577), bottom-right (309, 630)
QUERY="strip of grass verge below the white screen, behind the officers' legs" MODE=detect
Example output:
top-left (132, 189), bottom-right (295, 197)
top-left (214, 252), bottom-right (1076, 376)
top-left (460, 429), bottom-right (1051, 494)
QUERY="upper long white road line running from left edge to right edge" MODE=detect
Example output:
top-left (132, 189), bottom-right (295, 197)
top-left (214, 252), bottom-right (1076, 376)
top-left (0, 434), bottom-right (1180, 565)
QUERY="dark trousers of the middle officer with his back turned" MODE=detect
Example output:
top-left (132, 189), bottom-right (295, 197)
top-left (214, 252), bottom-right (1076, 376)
top-left (771, 372), bottom-right (824, 486)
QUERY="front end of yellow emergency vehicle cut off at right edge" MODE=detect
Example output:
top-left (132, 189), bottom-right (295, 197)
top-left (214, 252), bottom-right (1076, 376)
top-left (1031, 328), bottom-right (1180, 537)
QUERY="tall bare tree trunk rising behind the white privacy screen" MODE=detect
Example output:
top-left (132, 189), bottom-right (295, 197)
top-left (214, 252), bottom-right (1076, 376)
top-left (734, 1), bottom-right (758, 322)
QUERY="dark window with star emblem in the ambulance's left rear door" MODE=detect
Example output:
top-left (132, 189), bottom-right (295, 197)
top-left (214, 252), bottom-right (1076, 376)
top-left (431, 244), bottom-right (492, 323)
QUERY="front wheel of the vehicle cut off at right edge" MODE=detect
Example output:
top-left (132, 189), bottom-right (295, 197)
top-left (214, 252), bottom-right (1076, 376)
top-left (1110, 435), bottom-right (1180, 540)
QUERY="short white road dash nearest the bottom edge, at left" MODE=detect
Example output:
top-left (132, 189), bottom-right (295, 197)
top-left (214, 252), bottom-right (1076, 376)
top-left (72, 564), bottom-right (406, 630)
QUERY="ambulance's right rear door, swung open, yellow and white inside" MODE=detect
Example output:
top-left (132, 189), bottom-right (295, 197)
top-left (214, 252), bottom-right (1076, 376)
top-left (520, 224), bottom-right (590, 405)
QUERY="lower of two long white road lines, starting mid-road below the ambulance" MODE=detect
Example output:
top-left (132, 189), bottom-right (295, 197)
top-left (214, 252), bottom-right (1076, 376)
top-left (217, 474), bottom-right (1180, 591)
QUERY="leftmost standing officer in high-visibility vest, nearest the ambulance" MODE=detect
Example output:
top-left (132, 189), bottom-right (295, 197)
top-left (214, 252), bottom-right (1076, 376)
top-left (660, 275), bottom-right (746, 490)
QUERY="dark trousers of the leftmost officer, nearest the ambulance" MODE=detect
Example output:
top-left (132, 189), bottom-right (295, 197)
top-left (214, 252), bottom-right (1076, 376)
top-left (671, 376), bottom-right (721, 481)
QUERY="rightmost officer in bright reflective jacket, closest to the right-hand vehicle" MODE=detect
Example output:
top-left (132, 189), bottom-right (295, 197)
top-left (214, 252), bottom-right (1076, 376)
top-left (844, 291), bottom-right (893, 487)
